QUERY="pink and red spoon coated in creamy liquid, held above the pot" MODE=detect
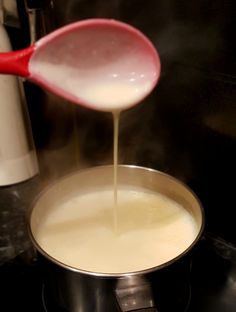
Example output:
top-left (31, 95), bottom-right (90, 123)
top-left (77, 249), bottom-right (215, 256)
top-left (0, 19), bottom-right (160, 111)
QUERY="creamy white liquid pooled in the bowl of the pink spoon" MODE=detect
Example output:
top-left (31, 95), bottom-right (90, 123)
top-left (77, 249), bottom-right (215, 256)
top-left (30, 56), bottom-right (153, 112)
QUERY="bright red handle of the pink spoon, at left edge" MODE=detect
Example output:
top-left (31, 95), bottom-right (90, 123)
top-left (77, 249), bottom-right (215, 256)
top-left (0, 45), bottom-right (35, 78)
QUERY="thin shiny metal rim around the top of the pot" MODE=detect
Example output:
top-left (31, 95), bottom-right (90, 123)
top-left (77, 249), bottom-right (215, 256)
top-left (27, 164), bottom-right (205, 278)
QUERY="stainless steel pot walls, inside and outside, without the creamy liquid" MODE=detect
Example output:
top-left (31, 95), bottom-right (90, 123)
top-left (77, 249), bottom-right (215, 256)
top-left (29, 166), bottom-right (204, 312)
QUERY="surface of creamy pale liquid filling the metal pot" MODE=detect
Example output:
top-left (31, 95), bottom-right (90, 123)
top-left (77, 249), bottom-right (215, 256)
top-left (33, 187), bottom-right (198, 273)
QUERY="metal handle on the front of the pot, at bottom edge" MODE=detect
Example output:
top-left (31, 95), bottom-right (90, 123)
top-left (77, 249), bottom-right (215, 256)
top-left (115, 276), bottom-right (158, 312)
